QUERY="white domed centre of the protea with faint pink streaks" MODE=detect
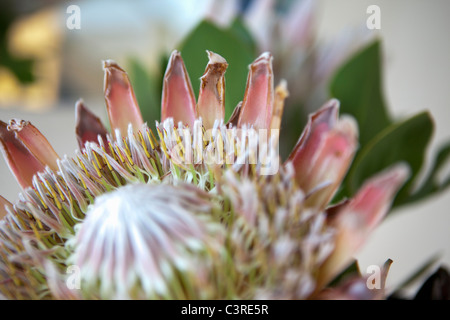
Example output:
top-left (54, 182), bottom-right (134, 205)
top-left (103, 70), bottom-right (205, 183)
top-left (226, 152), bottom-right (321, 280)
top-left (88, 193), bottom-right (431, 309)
top-left (71, 184), bottom-right (225, 299)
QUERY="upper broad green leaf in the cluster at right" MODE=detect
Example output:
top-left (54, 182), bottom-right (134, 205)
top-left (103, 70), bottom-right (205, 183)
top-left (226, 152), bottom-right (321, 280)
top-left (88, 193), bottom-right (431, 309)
top-left (330, 41), bottom-right (391, 146)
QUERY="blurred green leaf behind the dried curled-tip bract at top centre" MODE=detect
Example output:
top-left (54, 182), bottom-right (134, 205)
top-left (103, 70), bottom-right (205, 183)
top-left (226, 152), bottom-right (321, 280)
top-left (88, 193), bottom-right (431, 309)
top-left (178, 21), bottom-right (254, 120)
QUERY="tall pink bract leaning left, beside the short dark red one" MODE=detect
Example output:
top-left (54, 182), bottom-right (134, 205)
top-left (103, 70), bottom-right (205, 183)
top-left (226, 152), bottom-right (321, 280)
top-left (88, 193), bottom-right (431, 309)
top-left (103, 60), bottom-right (144, 135)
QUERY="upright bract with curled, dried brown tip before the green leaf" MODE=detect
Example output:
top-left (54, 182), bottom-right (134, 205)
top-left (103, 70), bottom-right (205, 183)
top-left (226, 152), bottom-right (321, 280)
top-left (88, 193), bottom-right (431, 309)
top-left (197, 51), bottom-right (228, 129)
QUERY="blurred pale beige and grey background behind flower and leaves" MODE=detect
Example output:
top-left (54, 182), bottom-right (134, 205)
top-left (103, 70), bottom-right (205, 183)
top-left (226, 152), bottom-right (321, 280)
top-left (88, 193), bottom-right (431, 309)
top-left (0, 0), bottom-right (450, 296)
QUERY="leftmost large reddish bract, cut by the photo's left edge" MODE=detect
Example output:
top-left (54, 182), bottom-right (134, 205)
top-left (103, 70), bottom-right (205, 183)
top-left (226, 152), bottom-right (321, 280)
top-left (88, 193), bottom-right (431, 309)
top-left (0, 121), bottom-right (45, 189)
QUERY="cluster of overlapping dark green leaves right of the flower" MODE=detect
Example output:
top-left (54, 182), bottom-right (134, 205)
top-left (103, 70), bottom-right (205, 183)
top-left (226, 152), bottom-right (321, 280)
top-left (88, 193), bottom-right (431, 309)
top-left (330, 41), bottom-right (450, 210)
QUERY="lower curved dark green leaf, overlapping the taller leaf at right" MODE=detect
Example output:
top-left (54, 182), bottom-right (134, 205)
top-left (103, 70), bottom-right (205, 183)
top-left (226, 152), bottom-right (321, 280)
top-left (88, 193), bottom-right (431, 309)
top-left (346, 112), bottom-right (433, 205)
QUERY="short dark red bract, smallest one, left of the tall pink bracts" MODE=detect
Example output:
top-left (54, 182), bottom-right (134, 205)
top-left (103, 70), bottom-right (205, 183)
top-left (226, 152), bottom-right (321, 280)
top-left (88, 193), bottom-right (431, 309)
top-left (75, 100), bottom-right (107, 149)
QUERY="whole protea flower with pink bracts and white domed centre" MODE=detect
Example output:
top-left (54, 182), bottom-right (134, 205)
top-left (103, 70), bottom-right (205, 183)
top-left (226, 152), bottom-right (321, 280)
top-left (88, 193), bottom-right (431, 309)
top-left (0, 51), bottom-right (408, 299)
